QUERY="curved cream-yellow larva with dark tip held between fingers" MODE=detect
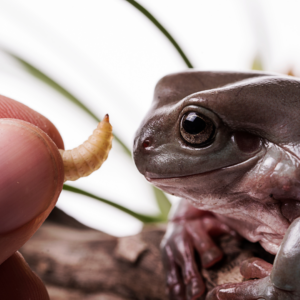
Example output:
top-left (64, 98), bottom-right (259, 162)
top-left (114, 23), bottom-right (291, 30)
top-left (59, 115), bottom-right (113, 181)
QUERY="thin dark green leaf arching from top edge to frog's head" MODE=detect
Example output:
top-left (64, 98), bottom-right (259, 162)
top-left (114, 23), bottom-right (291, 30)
top-left (125, 0), bottom-right (193, 68)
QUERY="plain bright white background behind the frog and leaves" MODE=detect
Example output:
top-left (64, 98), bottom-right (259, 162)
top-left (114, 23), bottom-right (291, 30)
top-left (0, 0), bottom-right (300, 236)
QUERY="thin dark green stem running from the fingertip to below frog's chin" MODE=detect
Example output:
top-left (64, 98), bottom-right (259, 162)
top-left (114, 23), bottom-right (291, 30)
top-left (63, 184), bottom-right (164, 223)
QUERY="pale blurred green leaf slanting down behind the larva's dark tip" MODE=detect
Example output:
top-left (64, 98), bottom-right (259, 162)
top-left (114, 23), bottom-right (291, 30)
top-left (7, 52), bottom-right (131, 156)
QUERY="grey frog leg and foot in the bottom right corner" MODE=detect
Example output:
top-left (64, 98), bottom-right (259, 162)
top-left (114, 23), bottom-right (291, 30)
top-left (206, 218), bottom-right (300, 300)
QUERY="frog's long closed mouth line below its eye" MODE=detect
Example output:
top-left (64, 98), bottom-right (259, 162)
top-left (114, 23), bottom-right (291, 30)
top-left (144, 156), bottom-right (259, 184)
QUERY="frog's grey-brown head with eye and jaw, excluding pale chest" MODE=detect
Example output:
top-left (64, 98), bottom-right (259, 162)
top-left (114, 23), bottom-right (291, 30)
top-left (134, 71), bottom-right (300, 200)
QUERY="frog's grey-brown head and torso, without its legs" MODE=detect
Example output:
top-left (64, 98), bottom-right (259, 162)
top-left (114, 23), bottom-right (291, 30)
top-left (134, 72), bottom-right (300, 253)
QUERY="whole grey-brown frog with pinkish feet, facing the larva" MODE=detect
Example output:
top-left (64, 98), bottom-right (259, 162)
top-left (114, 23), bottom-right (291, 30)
top-left (134, 71), bottom-right (300, 300)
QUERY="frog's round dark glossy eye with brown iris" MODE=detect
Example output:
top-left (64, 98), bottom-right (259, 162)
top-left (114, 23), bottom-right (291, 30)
top-left (180, 112), bottom-right (215, 147)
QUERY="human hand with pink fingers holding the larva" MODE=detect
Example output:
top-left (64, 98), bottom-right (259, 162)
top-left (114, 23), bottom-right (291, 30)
top-left (0, 96), bottom-right (64, 300)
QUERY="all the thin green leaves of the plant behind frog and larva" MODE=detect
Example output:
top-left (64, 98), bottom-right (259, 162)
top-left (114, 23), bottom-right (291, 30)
top-left (6, 0), bottom-right (193, 223)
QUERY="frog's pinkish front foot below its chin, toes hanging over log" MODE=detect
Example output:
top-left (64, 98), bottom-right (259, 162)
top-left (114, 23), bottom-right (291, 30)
top-left (161, 200), bottom-right (235, 300)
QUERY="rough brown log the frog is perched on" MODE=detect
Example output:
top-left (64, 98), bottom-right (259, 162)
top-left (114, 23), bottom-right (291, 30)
top-left (20, 208), bottom-right (272, 300)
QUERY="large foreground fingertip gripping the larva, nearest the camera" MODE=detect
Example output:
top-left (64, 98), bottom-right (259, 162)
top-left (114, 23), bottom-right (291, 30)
top-left (0, 119), bottom-right (64, 264)
